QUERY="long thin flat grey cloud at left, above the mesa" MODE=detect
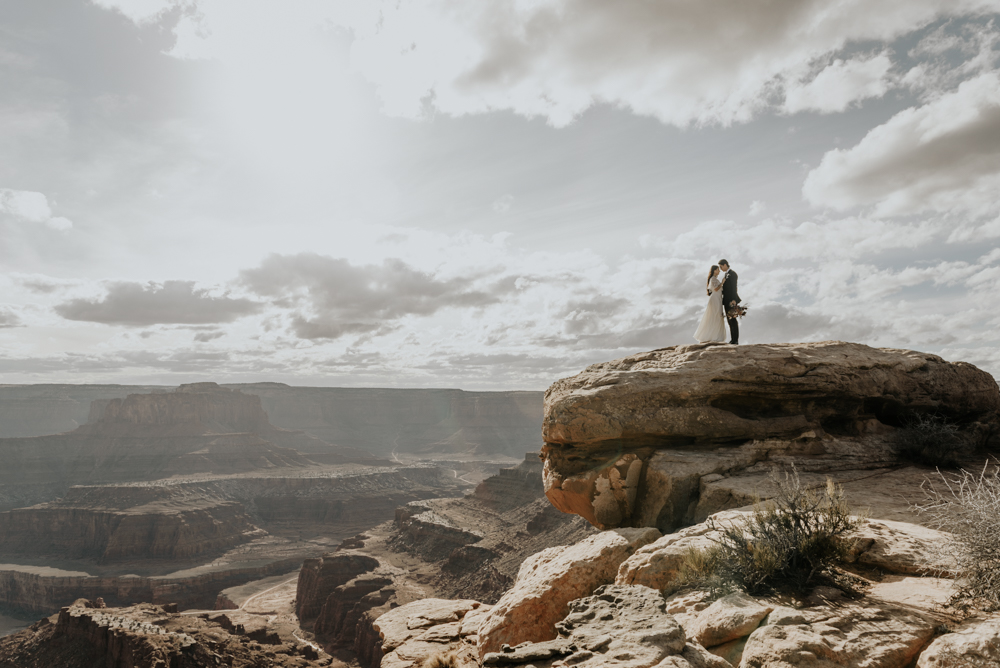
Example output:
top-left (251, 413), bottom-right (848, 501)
top-left (55, 281), bottom-right (262, 327)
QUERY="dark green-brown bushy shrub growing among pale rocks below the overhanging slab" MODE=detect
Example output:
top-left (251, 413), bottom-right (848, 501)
top-left (678, 467), bottom-right (858, 595)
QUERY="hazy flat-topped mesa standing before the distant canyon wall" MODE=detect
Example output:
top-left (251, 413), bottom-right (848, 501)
top-left (0, 383), bottom-right (316, 485)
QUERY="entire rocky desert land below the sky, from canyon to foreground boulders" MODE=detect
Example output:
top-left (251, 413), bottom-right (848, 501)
top-left (0, 342), bottom-right (1000, 668)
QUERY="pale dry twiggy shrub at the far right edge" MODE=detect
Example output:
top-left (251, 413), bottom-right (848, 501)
top-left (913, 462), bottom-right (1000, 610)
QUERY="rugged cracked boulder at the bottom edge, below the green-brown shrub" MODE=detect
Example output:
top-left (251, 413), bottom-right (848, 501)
top-left (740, 603), bottom-right (936, 668)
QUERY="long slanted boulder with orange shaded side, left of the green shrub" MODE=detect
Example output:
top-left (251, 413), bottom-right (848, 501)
top-left (478, 529), bottom-right (660, 657)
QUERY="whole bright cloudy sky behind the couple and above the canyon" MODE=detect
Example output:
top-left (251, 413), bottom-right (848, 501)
top-left (0, 0), bottom-right (1000, 390)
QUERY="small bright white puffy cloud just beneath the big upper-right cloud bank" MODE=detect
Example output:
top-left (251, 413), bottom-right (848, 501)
top-left (784, 52), bottom-right (892, 113)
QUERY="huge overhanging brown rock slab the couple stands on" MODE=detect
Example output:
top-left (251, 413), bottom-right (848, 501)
top-left (542, 342), bottom-right (1000, 531)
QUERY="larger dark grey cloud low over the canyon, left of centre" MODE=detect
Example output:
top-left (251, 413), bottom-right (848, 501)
top-left (240, 253), bottom-right (512, 339)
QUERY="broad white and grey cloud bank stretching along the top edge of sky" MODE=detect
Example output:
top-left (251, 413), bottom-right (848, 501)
top-left (95, 0), bottom-right (997, 126)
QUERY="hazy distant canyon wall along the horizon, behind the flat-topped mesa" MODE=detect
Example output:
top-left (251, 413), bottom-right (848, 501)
top-left (0, 383), bottom-right (542, 456)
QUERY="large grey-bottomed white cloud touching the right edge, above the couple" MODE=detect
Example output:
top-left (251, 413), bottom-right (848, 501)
top-left (802, 72), bottom-right (1000, 215)
